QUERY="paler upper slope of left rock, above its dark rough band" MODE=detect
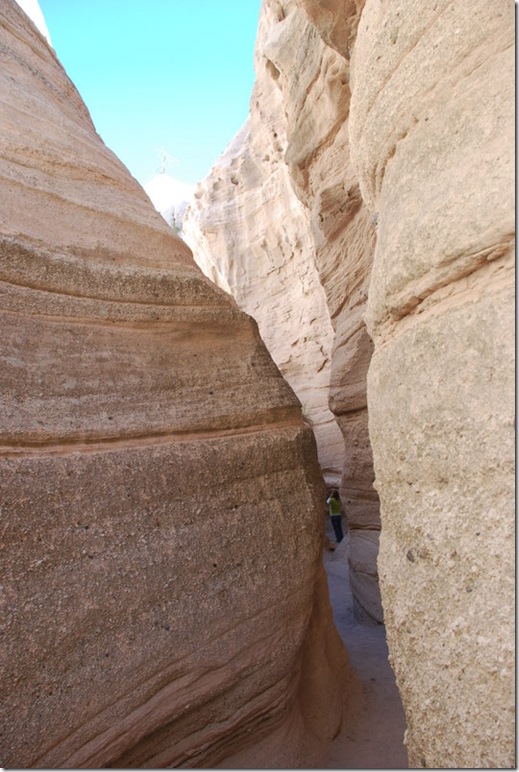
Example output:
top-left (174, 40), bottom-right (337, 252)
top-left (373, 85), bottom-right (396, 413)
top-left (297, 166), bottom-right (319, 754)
top-left (0, 2), bottom-right (192, 268)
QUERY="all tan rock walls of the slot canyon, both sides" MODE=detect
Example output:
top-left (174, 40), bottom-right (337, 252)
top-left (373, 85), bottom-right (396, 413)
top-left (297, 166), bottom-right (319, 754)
top-left (0, 0), bottom-right (515, 769)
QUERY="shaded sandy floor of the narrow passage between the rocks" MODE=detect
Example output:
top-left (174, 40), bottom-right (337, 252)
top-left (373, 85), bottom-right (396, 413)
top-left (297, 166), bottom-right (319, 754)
top-left (324, 518), bottom-right (408, 769)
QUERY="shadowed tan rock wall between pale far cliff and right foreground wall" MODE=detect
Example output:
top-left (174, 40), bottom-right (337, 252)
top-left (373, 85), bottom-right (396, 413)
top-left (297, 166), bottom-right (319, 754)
top-left (263, 2), bottom-right (383, 622)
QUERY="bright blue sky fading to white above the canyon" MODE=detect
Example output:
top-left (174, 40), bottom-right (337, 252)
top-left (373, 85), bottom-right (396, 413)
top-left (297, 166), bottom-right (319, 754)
top-left (39, 0), bottom-right (261, 185)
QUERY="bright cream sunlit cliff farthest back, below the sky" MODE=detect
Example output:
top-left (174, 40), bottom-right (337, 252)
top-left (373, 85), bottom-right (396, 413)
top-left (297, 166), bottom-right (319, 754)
top-left (183, 3), bottom-right (344, 488)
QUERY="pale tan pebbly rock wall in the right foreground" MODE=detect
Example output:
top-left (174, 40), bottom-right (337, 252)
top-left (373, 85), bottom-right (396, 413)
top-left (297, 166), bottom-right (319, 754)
top-left (351, 0), bottom-right (515, 768)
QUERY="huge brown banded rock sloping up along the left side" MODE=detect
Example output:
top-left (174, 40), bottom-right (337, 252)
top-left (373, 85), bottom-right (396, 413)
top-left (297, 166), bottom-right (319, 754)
top-left (0, 0), bottom-right (354, 768)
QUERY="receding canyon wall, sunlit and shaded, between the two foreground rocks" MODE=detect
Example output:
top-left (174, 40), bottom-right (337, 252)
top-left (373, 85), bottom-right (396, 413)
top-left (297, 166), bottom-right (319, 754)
top-left (184, 0), bottom-right (383, 622)
